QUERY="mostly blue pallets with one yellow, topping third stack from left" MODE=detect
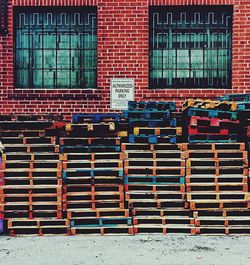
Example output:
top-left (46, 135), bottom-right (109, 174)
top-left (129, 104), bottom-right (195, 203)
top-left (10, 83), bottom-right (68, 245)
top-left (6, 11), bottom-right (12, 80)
top-left (122, 101), bottom-right (182, 144)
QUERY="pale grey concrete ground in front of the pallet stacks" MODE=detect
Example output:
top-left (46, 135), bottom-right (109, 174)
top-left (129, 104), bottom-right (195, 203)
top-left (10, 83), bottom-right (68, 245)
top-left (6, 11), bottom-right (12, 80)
top-left (0, 235), bottom-right (250, 265)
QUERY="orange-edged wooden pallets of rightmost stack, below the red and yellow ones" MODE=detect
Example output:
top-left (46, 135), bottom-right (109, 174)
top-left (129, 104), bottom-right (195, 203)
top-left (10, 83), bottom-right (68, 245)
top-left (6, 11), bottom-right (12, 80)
top-left (184, 143), bottom-right (250, 234)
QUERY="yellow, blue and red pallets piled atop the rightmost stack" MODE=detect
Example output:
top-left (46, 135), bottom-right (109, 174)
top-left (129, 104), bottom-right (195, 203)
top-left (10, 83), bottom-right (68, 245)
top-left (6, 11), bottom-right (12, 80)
top-left (183, 99), bottom-right (239, 143)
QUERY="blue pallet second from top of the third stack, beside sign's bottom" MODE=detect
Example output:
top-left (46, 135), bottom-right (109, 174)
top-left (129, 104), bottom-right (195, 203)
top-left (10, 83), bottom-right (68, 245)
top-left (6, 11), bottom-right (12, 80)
top-left (121, 109), bottom-right (171, 119)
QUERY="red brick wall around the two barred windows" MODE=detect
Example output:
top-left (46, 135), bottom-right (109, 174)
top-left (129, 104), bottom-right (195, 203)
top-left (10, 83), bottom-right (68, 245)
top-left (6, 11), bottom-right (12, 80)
top-left (0, 0), bottom-right (250, 114)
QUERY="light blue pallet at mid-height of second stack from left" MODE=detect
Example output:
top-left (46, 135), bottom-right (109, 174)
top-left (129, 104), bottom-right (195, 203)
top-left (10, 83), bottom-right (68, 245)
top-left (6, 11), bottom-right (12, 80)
top-left (62, 168), bottom-right (123, 180)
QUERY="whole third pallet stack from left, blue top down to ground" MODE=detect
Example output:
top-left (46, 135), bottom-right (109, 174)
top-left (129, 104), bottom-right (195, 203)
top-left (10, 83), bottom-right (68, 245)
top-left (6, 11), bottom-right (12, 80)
top-left (122, 102), bottom-right (194, 234)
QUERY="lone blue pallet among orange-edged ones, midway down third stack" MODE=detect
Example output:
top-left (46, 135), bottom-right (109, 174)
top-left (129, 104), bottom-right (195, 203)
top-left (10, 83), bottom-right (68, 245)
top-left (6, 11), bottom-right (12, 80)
top-left (123, 176), bottom-right (185, 185)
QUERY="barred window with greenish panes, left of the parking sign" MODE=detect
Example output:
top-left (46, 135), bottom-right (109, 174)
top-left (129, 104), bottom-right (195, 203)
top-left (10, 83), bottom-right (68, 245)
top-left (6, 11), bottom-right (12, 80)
top-left (15, 7), bottom-right (97, 88)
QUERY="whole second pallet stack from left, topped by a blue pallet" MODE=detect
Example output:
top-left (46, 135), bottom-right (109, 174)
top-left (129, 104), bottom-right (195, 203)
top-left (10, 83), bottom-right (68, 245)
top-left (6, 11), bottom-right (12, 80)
top-left (60, 114), bottom-right (133, 235)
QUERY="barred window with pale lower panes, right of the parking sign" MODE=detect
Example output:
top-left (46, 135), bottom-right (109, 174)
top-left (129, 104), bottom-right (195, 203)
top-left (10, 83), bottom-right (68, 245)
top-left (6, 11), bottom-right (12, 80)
top-left (149, 6), bottom-right (233, 88)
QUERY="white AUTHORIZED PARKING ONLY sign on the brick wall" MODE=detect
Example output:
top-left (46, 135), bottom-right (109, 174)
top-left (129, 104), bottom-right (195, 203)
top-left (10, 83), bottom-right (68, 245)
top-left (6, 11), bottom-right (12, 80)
top-left (110, 78), bottom-right (134, 110)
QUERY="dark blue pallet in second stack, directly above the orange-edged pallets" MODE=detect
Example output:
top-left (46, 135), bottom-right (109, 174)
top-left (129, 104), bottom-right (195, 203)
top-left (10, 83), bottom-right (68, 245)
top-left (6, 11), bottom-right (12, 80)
top-left (59, 145), bottom-right (121, 154)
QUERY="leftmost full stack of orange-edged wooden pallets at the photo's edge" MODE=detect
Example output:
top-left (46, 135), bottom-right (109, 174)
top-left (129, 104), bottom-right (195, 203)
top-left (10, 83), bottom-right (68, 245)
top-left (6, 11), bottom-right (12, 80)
top-left (0, 115), bottom-right (69, 235)
